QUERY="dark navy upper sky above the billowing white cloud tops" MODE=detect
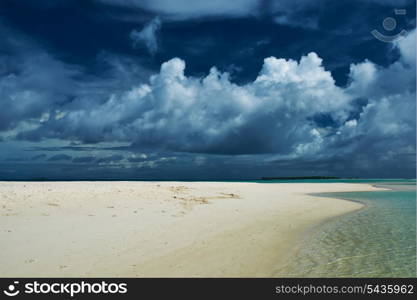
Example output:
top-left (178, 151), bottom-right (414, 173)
top-left (0, 0), bottom-right (415, 84)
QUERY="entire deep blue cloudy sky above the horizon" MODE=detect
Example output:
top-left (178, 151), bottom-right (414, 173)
top-left (0, 0), bottom-right (416, 180)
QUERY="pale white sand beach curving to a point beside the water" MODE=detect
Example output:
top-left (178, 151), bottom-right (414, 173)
top-left (0, 182), bottom-right (384, 277)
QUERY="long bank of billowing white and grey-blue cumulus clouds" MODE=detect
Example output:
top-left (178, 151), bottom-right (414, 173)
top-left (7, 32), bottom-right (415, 163)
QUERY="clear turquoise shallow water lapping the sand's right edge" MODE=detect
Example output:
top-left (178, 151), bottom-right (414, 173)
top-left (275, 180), bottom-right (416, 277)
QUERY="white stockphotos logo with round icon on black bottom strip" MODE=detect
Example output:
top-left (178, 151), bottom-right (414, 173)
top-left (3, 280), bottom-right (127, 297)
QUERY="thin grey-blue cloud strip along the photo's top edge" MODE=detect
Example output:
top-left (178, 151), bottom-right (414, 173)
top-left (96, 0), bottom-right (413, 28)
